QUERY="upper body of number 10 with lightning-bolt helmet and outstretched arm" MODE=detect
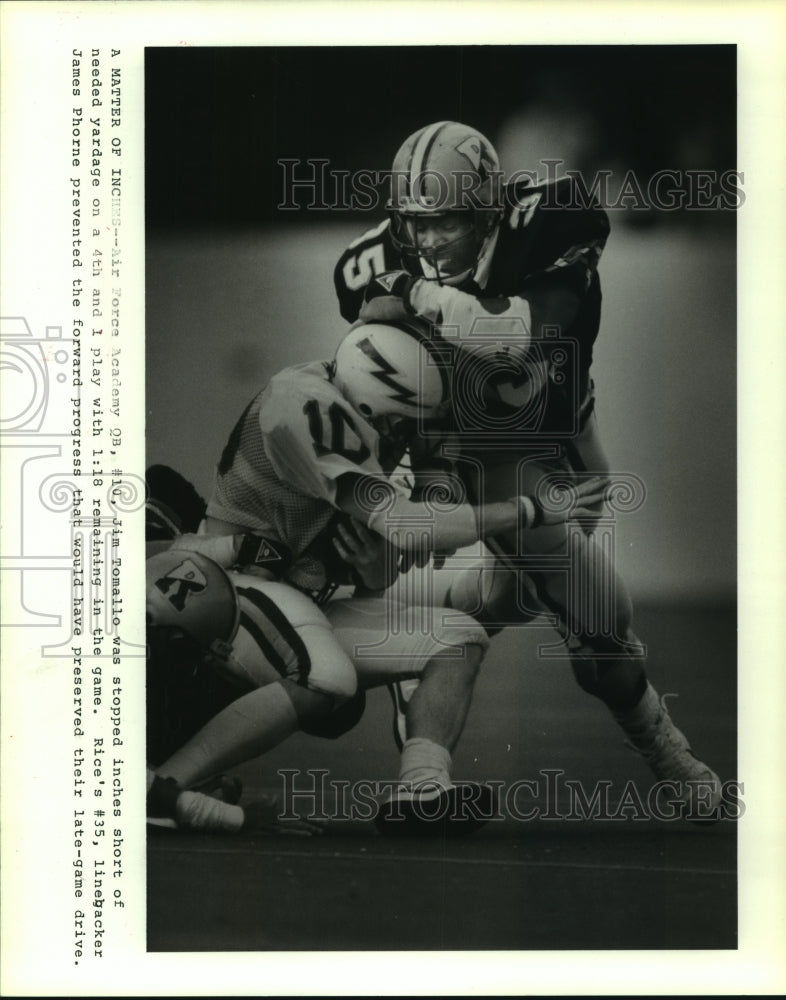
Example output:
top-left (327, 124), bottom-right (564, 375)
top-left (206, 320), bottom-right (605, 594)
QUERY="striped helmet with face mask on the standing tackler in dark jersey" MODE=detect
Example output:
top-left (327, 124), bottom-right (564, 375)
top-left (387, 122), bottom-right (503, 285)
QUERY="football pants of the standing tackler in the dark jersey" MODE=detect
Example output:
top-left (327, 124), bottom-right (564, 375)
top-left (461, 414), bottom-right (646, 711)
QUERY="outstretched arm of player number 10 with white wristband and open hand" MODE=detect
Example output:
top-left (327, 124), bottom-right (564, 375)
top-left (336, 473), bottom-right (607, 553)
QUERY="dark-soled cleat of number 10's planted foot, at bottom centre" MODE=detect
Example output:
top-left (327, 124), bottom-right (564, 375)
top-left (374, 781), bottom-right (497, 838)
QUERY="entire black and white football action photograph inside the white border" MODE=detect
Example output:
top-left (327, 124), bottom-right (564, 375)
top-left (145, 45), bottom-right (745, 951)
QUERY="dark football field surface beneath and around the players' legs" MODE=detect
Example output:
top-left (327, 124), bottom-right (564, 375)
top-left (147, 606), bottom-right (745, 952)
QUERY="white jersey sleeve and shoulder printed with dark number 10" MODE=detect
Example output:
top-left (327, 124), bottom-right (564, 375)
top-left (259, 369), bottom-right (396, 505)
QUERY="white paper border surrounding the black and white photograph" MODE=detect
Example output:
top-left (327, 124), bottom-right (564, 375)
top-left (0, 0), bottom-right (786, 996)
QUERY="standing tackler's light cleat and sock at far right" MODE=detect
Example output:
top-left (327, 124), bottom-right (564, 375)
top-left (621, 685), bottom-right (722, 823)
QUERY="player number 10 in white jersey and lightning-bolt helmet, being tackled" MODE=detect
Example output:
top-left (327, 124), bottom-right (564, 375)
top-left (167, 324), bottom-right (605, 830)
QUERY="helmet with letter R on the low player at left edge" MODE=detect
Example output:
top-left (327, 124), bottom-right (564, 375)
top-left (145, 548), bottom-right (240, 650)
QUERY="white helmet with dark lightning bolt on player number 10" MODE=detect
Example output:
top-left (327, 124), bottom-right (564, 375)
top-left (333, 322), bottom-right (450, 426)
